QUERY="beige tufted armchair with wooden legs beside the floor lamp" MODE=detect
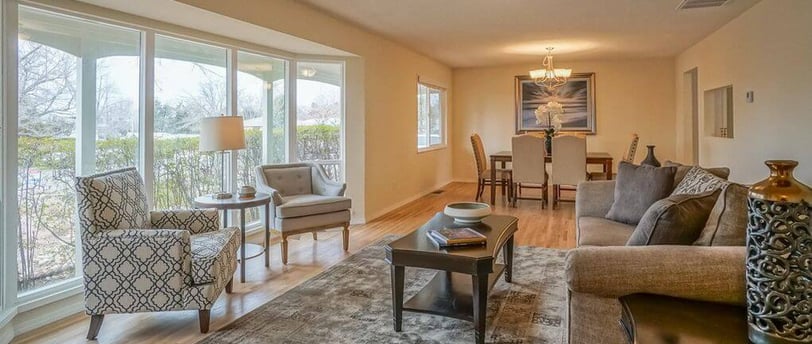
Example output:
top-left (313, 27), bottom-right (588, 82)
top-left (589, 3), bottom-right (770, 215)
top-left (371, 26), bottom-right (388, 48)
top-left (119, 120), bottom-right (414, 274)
top-left (257, 163), bottom-right (352, 264)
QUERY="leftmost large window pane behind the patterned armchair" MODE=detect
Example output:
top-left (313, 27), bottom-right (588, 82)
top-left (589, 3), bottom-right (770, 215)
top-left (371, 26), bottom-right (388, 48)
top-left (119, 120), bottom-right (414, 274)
top-left (17, 7), bottom-right (140, 292)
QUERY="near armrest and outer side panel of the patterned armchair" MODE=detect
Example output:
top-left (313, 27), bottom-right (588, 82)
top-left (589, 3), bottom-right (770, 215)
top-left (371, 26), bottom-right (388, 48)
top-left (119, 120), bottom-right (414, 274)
top-left (82, 229), bottom-right (192, 314)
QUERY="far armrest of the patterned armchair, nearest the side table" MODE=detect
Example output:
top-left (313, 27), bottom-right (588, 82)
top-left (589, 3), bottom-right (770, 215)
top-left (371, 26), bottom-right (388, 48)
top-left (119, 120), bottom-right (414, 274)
top-left (149, 209), bottom-right (220, 234)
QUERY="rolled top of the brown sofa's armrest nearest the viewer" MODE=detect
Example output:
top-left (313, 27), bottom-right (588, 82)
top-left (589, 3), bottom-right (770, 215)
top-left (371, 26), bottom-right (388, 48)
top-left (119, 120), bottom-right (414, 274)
top-left (566, 246), bottom-right (746, 304)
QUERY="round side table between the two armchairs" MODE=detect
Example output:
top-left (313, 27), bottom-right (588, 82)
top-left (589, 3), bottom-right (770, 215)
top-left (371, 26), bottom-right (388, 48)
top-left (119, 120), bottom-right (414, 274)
top-left (195, 193), bottom-right (271, 283)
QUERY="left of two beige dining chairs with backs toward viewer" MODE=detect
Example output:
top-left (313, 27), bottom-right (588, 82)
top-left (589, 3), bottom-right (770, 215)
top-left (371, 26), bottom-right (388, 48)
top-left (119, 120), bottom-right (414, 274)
top-left (511, 135), bottom-right (547, 208)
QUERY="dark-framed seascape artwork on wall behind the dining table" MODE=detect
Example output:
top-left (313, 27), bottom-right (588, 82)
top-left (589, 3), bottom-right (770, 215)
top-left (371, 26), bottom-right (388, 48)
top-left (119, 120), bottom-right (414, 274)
top-left (516, 73), bottom-right (596, 135)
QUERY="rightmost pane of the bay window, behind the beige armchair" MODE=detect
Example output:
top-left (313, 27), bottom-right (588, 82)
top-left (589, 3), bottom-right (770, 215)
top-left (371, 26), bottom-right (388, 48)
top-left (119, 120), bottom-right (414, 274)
top-left (296, 62), bottom-right (344, 180)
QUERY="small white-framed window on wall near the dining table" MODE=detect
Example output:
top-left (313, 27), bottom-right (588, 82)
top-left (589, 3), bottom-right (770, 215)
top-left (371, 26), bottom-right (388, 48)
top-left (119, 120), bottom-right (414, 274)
top-left (417, 83), bottom-right (445, 151)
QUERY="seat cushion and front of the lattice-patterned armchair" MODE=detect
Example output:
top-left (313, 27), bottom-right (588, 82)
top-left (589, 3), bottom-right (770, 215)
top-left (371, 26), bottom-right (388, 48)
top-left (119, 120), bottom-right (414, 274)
top-left (189, 227), bottom-right (240, 284)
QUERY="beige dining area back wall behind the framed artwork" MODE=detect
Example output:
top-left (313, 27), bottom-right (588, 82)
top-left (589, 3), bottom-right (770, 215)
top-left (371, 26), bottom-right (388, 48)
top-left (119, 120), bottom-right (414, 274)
top-left (453, 58), bottom-right (675, 181)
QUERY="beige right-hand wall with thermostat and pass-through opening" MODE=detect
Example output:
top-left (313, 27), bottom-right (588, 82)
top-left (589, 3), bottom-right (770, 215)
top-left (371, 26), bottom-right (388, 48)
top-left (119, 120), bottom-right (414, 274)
top-left (675, 0), bottom-right (812, 183)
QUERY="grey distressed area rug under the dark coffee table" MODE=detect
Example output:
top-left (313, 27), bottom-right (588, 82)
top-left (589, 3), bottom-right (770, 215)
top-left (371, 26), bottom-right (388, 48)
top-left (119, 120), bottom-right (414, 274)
top-left (200, 236), bottom-right (567, 344)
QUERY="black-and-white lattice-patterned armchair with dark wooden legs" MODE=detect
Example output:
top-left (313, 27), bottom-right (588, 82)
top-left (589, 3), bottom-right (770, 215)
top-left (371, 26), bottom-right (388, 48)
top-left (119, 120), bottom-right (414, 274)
top-left (76, 168), bottom-right (240, 339)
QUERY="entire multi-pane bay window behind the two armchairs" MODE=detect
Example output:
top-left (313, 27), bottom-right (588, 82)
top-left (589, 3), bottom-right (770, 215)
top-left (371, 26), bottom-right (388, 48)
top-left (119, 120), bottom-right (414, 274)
top-left (9, 5), bottom-right (344, 301)
